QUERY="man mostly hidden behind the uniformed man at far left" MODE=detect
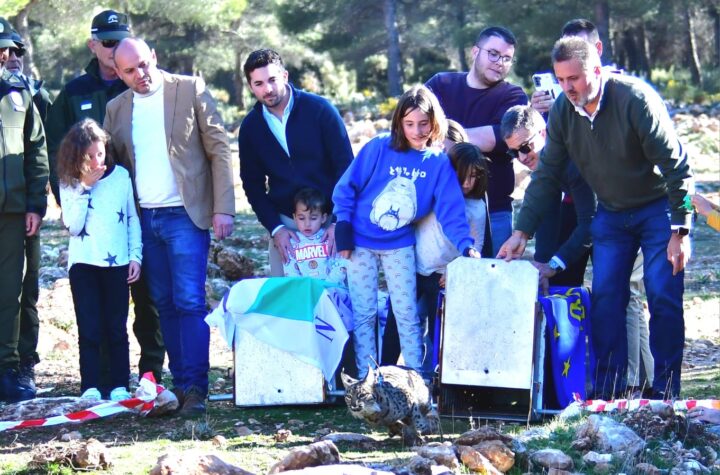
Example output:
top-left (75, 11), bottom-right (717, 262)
top-left (5, 31), bottom-right (52, 390)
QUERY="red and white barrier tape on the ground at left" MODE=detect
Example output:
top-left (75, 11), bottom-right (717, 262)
top-left (0, 373), bottom-right (166, 432)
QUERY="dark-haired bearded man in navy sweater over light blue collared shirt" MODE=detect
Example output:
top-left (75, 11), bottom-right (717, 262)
top-left (238, 49), bottom-right (353, 276)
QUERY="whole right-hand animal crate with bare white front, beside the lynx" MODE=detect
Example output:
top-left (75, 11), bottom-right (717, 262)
top-left (438, 257), bottom-right (545, 421)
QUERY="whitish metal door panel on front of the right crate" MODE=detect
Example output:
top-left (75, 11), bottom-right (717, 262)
top-left (440, 257), bottom-right (538, 390)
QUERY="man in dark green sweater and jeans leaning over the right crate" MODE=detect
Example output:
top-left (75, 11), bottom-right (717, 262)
top-left (498, 37), bottom-right (694, 399)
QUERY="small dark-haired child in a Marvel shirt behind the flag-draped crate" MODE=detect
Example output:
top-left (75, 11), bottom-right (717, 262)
top-left (283, 188), bottom-right (346, 285)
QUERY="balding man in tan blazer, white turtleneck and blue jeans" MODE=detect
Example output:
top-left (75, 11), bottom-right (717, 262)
top-left (104, 38), bottom-right (235, 413)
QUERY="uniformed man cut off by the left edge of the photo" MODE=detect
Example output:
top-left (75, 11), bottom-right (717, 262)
top-left (0, 17), bottom-right (48, 402)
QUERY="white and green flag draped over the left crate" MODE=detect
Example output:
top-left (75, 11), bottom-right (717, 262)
top-left (205, 277), bottom-right (348, 381)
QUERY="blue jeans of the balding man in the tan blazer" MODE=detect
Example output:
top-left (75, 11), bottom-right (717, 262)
top-left (140, 206), bottom-right (210, 393)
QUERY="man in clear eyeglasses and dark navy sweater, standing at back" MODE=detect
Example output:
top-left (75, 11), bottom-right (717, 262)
top-left (425, 26), bottom-right (528, 257)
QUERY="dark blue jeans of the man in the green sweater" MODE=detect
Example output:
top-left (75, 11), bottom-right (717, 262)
top-left (591, 198), bottom-right (685, 398)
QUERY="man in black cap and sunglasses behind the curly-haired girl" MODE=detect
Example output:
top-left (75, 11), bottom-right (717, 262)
top-left (46, 10), bottom-right (165, 390)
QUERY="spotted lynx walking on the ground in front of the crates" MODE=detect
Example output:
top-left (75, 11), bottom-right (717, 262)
top-left (341, 366), bottom-right (439, 445)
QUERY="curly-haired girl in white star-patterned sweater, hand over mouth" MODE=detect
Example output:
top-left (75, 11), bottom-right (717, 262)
top-left (57, 119), bottom-right (142, 400)
